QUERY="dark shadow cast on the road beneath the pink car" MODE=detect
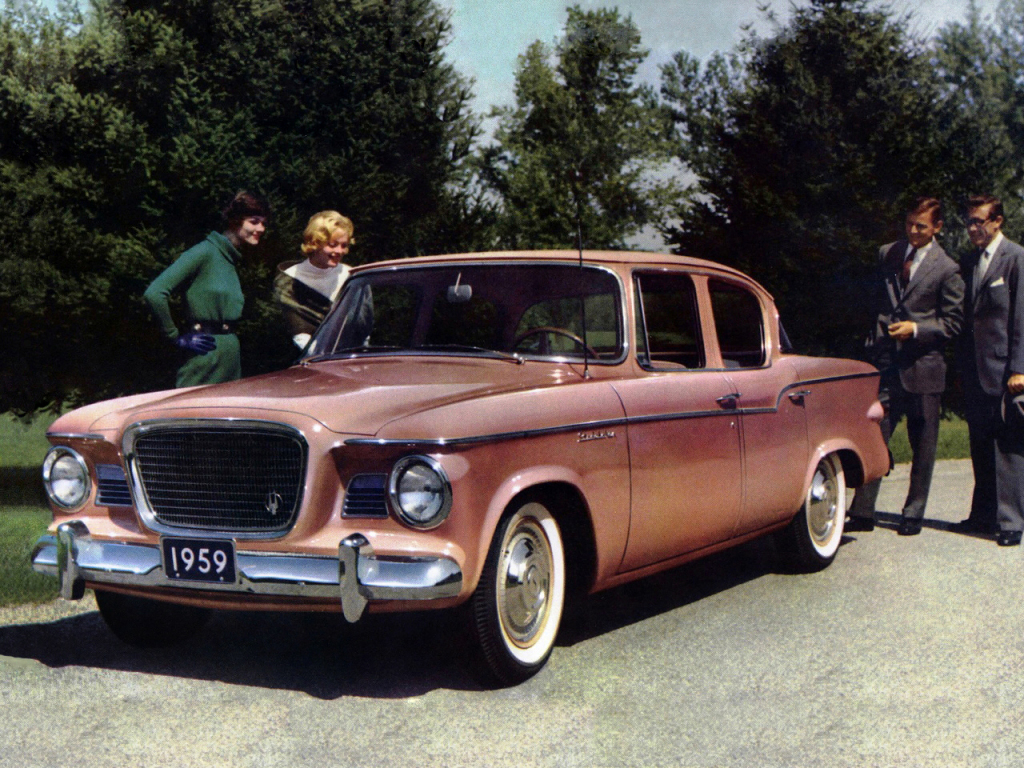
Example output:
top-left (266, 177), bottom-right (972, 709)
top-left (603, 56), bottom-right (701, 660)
top-left (0, 539), bottom-right (811, 699)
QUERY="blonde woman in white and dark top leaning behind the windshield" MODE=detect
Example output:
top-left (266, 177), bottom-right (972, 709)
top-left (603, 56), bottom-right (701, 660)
top-left (273, 211), bottom-right (355, 349)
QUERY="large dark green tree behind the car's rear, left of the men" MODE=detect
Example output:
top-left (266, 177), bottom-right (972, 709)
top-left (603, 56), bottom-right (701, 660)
top-left (663, 0), bottom-right (948, 355)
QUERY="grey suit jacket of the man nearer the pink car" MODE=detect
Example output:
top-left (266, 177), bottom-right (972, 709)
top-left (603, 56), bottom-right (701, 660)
top-left (868, 240), bottom-right (964, 394)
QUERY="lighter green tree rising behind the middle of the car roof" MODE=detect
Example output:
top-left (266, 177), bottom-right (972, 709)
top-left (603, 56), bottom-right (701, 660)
top-left (481, 6), bottom-right (672, 248)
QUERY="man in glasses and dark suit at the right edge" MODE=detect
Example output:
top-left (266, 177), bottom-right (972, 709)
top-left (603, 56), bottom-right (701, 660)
top-left (956, 196), bottom-right (1024, 547)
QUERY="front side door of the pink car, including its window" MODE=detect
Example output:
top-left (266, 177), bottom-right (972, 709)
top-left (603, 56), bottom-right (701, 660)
top-left (614, 270), bottom-right (742, 570)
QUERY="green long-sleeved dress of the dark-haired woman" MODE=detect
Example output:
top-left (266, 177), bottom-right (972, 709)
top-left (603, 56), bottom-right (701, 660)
top-left (143, 232), bottom-right (245, 387)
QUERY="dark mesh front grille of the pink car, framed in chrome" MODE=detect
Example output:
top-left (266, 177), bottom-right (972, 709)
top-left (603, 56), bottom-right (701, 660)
top-left (127, 422), bottom-right (306, 534)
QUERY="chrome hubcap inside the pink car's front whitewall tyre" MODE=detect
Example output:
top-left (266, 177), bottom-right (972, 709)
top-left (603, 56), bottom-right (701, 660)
top-left (498, 520), bottom-right (551, 647)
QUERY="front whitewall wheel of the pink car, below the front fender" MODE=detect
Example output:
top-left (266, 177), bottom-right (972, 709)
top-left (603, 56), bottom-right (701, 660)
top-left (471, 502), bottom-right (565, 685)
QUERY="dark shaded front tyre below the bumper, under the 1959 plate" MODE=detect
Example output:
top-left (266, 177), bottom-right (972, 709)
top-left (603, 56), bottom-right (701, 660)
top-left (96, 591), bottom-right (212, 648)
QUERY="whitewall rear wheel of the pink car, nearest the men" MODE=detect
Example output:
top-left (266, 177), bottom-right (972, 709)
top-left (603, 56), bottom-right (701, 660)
top-left (778, 454), bottom-right (846, 570)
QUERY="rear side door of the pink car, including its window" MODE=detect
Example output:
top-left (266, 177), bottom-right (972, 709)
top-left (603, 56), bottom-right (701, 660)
top-left (708, 279), bottom-right (809, 534)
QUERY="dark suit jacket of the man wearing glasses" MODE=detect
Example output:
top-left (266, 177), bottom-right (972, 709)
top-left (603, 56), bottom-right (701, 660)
top-left (957, 238), bottom-right (1024, 396)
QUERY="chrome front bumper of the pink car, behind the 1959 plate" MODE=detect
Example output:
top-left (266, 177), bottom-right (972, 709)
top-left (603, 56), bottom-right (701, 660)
top-left (32, 521), bottom-right (462, 622)
